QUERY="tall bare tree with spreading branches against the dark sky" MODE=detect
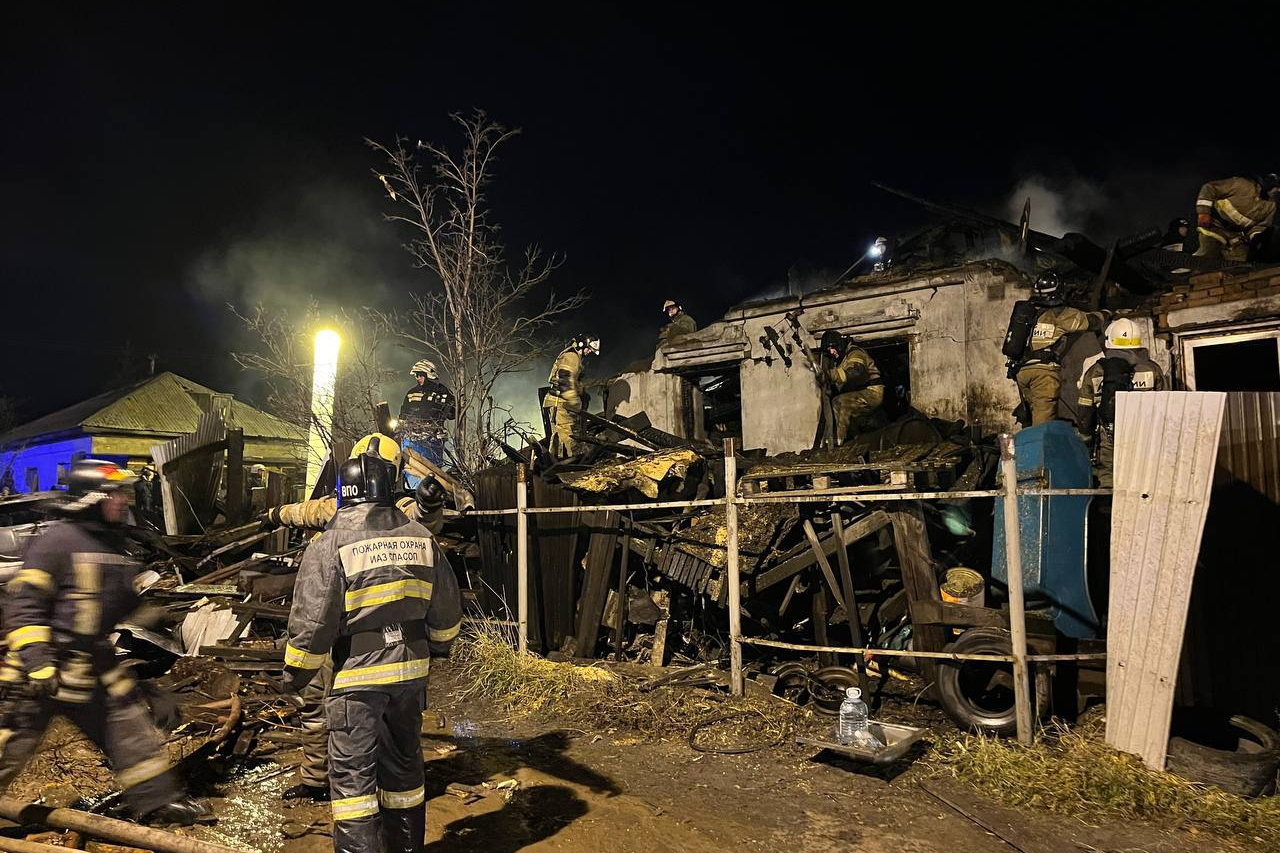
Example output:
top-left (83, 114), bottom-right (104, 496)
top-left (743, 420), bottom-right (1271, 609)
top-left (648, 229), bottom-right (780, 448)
top-left (366, 111), bottom-right (586, 479)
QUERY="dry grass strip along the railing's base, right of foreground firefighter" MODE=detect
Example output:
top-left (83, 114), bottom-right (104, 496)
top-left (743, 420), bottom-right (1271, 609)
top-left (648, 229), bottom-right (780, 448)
top-left (453, 625), bottom-right (805, 748)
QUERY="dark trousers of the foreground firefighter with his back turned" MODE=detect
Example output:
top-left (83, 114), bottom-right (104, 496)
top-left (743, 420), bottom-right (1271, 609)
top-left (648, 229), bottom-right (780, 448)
top-left (325, 681), bottom-right (426, 853)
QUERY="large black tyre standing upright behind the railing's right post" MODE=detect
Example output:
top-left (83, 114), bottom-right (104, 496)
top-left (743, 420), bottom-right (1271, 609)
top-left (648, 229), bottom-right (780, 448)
top-left (937, 628), bottom-right (1048, 735)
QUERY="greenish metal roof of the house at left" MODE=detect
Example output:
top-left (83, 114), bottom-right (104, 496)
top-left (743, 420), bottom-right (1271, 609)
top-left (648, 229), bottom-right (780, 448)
top-left (0, 373), bottom-right (306, 446)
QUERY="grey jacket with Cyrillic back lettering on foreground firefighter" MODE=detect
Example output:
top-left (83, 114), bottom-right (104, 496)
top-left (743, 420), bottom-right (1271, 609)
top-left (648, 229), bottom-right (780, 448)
top-left (284, 503), bottom-right (462, 693)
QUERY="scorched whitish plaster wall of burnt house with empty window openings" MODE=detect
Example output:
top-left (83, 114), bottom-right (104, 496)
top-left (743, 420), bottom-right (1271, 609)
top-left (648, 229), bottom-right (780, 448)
top-left (608, 260), bottom-right (1030, 455)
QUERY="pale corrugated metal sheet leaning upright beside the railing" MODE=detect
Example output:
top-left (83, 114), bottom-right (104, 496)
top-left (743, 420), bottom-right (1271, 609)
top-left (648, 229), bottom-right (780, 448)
top-left (1107, 391), bottom-right (1226, 770)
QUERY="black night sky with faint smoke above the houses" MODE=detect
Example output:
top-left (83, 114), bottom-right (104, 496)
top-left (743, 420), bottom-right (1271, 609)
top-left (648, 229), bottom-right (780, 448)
top-left (0, 3), bottom-right (1280, 418)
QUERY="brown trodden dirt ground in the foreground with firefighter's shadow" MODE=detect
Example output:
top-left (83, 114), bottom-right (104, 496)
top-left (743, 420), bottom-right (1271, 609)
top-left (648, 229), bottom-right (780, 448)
top-left (0, 663), bottom-right (1247, 853)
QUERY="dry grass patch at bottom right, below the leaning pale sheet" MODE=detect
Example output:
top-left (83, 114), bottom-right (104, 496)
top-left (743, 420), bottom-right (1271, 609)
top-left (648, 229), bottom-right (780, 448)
top-left (932, 721), bottom-right (1280, 849)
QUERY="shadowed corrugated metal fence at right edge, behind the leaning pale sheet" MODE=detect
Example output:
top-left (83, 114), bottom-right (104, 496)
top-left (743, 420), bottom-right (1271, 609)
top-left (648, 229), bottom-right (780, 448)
top-left (1176, 392), bottom-right (1280, 725)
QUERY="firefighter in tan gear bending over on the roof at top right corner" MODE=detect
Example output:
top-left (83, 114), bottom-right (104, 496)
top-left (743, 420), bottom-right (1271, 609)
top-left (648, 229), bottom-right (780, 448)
top-left (1196, 172), bottom-right (1280, 260)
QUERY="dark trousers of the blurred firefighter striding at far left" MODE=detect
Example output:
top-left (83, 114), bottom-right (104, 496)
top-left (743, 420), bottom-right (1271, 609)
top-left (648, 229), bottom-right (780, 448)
top-left (0, 686), bottom-right (184, 816)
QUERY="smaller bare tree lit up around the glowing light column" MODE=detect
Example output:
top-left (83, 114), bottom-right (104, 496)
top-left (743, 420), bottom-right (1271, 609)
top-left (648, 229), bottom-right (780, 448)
top-left (228, 304), bottom-right (397, 468)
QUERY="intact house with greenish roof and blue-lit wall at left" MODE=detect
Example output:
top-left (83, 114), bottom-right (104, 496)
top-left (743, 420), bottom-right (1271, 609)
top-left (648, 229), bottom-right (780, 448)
top-left (0, 373), bottom-right (306, 492)
